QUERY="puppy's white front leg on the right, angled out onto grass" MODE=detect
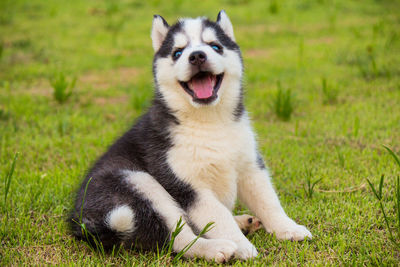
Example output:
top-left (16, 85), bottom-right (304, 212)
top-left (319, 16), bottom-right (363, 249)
top-left (238, 163), bottom-right (312, 241)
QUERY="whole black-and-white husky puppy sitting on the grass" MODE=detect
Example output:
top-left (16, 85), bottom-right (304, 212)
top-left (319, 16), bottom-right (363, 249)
top-left (70, 11), bottom-right (312, 262)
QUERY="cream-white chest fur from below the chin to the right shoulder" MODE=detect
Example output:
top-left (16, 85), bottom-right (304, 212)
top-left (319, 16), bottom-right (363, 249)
top-left (167, 115), bottom-right (256, 209)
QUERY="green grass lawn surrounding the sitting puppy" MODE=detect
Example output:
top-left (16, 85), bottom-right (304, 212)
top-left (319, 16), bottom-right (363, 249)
top-left (0, 0), bottom-right (400, 266)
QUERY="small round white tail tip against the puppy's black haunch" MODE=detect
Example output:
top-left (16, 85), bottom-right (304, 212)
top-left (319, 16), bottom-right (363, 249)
top-left (106, 205), bottom-right (135, 234)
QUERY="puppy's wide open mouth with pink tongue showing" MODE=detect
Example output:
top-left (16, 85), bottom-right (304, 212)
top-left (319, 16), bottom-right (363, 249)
top-left (179, 71), bottom-right (224, 104)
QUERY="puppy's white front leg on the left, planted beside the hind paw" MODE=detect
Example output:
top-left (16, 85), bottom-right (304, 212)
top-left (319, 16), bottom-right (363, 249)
top-left (187, 190), bottom-right (257, 259)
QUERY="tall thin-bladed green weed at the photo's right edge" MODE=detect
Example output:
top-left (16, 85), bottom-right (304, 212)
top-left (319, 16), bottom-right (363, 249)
top-left (367, 146), bottom-right (400, 248)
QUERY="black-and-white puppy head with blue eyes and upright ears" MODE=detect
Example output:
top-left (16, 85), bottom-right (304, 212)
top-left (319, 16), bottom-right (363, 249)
top-left (151, 11), bottom-right (243, 107)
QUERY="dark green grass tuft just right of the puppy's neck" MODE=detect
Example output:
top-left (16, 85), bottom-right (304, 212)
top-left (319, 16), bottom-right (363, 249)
top-left (271, 82), bottom-right (295, 121)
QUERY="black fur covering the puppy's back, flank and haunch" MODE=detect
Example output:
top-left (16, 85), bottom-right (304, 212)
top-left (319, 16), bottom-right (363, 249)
top-left (69, 93), bottom-right (196, 249)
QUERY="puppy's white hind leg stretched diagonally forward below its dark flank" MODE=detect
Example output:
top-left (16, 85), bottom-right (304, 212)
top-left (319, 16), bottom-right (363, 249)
top-left (124, 171), bottom-right (237, 263)
